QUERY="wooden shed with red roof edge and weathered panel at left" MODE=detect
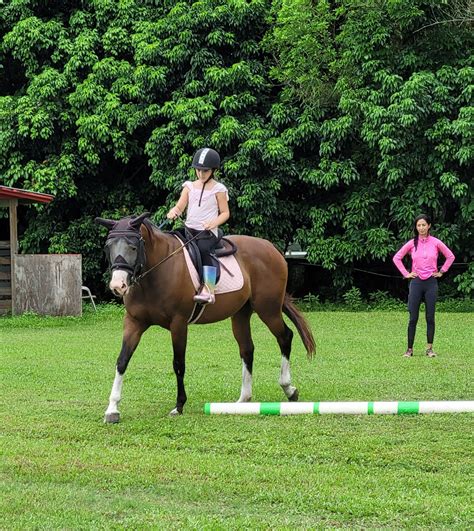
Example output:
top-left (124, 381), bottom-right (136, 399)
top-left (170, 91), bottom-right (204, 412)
top-left (0, 186), bottom-right (82, 315)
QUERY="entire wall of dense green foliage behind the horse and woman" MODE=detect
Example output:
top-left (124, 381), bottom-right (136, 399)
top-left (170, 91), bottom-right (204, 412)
top-left (0, 0), bottom-right (474, 294)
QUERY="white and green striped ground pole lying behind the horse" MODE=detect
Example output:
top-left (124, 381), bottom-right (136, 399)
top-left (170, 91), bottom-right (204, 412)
top-left (204, 400), bottom-right (474, 415)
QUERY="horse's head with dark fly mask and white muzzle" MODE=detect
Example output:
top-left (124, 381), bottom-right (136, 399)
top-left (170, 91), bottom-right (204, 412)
top-left (95, 212), bottom-right (150, 297)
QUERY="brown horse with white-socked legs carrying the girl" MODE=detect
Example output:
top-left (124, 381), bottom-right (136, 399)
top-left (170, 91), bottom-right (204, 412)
top-left (96, 213), bottom-right (315, 422)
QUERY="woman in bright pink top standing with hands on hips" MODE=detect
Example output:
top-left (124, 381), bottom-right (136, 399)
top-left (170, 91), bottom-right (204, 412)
top-left (393, 214), bottom-right (454, 358)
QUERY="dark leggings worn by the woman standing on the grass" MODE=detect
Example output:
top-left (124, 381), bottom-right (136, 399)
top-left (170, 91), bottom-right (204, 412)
top-left (408, 277), bottom-right (438, 348)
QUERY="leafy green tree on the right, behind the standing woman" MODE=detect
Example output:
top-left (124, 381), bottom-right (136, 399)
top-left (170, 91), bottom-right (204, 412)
top-left (268, 0), bottom-right (474, 293)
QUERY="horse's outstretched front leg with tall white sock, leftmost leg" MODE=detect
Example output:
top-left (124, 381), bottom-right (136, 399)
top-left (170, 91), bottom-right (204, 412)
top-left (104, 314), bottom-right (147, 423)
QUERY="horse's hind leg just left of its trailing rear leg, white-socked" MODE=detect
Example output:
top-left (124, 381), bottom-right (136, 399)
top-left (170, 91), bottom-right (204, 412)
top-left (232, 303), bottom-right (254, 402)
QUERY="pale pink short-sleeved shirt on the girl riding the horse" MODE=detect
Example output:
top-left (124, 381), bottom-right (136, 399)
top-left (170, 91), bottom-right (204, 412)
top-left (183, 181), bottom-right (229, 236)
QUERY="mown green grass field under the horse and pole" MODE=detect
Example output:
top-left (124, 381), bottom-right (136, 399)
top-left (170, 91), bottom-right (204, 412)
top-left (0, 307), bottom-right (474, 529)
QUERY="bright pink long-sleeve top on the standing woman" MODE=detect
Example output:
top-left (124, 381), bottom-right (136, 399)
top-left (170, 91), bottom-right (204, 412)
top-left (393, 236), bottom-right (454, 280)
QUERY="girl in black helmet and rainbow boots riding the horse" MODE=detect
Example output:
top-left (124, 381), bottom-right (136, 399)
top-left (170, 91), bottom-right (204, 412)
top-left (167, 148), bottom-right (230, 304)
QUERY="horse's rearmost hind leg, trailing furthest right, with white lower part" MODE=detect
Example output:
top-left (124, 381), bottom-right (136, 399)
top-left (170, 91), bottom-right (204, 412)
top-left (256, 306), bottom-right (298, 402)
